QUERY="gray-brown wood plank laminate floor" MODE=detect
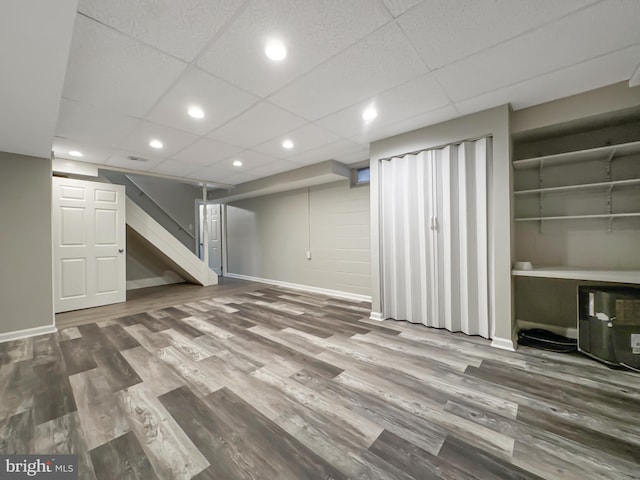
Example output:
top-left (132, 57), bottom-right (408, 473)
top-left (0, 282), bottom-right (640, 480)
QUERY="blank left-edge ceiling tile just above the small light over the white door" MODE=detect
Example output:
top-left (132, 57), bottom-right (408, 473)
top-left (56, 98), bottom-right (140, 146)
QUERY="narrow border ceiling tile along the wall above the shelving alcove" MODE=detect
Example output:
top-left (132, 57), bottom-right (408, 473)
top-left (456, 45), bottom-right (640, 115)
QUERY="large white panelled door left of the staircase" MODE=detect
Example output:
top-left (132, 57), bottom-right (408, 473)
top-left (53, 177), bottom-right (126, 313)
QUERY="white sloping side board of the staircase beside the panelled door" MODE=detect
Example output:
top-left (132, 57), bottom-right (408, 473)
top-left (126, 197), bottom-right (218, 286)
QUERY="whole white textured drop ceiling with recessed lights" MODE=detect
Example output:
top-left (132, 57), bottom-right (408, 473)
top-left (7, 0), bottom-right (640, 185)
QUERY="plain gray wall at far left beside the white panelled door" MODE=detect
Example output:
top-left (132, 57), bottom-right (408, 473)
top-left (0, 152), bottom-right (53, 334)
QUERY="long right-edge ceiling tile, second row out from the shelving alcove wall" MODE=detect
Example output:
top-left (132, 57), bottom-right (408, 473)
top-left (435, 1), bottom-right (640, 102)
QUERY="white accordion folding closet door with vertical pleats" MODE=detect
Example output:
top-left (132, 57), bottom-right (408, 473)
top-left (380, 135), bottom-right (490, 338)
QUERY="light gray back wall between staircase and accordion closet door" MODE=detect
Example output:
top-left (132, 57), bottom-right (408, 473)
top-left (226, 180), bottom-right (371, 296)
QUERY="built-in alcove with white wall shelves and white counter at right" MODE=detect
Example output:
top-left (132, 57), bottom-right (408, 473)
top-left (511, 109), bottom-right (640, 337)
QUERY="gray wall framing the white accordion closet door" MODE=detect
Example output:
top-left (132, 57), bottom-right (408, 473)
top-left (371, 105), bottom-right (514, 341)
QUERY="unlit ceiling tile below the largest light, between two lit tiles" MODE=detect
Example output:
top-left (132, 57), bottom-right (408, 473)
top-left (208, 102), bottom-right (307, 148)
